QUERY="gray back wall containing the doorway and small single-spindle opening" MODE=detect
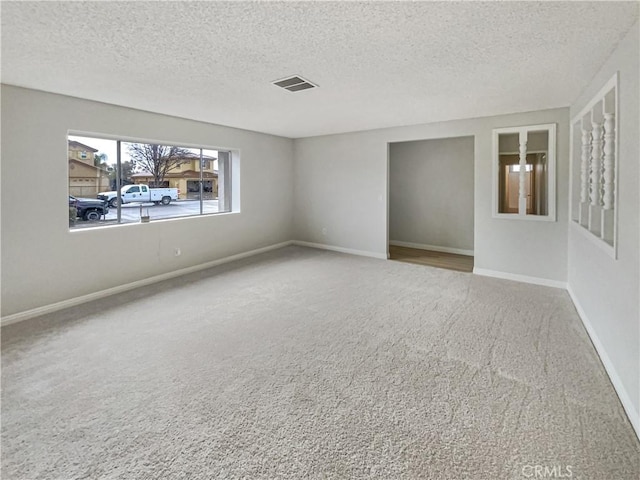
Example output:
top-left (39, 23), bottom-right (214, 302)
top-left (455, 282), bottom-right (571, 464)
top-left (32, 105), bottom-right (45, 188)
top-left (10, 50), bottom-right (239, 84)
top-left (294, 108), bottom-right (569, 282)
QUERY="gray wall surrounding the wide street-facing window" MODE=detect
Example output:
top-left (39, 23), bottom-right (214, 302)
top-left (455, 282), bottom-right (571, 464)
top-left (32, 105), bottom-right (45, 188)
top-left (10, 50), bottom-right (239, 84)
top-left (1, 85), bottom-right (293, 316)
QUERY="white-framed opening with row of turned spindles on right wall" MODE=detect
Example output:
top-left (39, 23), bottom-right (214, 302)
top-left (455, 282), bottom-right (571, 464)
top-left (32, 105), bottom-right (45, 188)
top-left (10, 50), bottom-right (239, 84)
top-left (571, 73), bottom-right (618, 258)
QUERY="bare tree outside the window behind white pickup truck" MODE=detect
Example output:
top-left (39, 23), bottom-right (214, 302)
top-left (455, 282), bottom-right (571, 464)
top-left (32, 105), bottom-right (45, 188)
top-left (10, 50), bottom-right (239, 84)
top-left (128, 143), bottom-right (191, 186)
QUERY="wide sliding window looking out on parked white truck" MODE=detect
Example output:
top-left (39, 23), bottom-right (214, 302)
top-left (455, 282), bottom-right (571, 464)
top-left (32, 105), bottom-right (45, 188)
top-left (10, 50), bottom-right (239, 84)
top-left (68, 134), bottom-right (237, 229)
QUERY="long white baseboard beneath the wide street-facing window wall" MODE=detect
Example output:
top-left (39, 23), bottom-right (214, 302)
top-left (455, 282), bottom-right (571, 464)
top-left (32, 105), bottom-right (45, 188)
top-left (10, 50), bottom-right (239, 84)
top-left (0, 241), bottom-right (292, 327)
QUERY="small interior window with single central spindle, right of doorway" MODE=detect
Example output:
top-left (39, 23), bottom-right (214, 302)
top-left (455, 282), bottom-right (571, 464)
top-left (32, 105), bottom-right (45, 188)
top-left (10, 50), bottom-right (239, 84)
top-left (493, 124), bottom-right (556, 221)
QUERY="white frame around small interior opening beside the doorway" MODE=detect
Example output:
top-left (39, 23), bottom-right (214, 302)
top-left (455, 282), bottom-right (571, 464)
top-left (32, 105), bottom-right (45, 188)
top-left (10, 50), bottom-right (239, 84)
top-left (491, 123), bottom-right (557, 222)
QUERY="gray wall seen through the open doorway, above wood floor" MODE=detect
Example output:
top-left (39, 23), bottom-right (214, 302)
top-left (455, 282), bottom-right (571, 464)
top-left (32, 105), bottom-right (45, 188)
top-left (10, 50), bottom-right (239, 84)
top-left (389, 137), bottom-right (473, 251)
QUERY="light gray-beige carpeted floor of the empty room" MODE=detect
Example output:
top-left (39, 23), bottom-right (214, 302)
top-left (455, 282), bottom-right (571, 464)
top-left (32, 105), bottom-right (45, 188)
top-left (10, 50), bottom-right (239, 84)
top-left (2, 247), bottom-right (640, 480)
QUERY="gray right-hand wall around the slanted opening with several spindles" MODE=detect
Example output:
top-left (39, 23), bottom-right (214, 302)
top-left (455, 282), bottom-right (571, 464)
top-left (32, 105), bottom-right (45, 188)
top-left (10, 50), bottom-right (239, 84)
top-left (569, 23), bottom-right (640, 435)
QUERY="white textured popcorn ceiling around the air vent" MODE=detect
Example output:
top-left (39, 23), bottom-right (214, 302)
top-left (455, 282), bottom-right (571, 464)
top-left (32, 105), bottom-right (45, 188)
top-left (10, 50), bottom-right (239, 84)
top-left (0, 1), bottom-right (638, 138)
